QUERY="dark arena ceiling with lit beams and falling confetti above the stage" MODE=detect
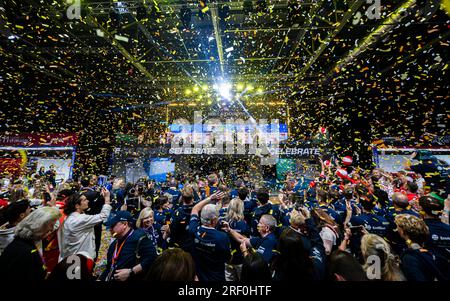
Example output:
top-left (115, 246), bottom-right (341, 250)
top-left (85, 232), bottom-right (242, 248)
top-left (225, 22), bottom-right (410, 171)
top-left (0, 0), bottom-right (450, 169)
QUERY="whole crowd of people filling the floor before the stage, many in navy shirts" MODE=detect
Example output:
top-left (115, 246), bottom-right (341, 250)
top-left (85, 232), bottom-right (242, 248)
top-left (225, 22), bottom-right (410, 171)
top-left (0, 150), bottom-right (450, 282)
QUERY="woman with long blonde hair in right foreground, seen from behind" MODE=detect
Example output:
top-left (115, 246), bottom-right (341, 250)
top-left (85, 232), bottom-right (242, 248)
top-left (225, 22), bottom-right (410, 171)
top-left (361, 234), bottom-right (406, 281)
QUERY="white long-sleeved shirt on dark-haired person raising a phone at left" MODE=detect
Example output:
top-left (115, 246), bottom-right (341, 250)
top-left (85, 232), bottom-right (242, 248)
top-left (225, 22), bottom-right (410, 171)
top-left (58, 204), bottom-right (112, 261)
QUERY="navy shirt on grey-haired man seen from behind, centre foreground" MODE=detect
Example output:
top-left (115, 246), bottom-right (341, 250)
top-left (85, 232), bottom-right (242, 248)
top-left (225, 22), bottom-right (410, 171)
top-left (189, 214), bottom-right (231, 281)
